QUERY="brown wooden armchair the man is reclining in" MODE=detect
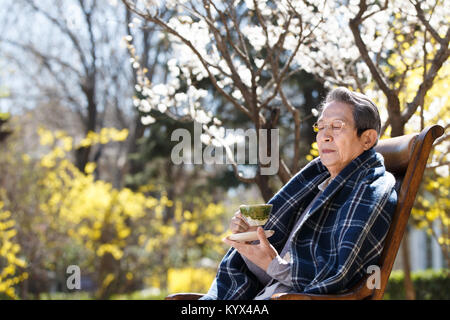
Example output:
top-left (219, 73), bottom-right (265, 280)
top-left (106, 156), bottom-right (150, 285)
top-left (166, 125), bottom-right (444, 300)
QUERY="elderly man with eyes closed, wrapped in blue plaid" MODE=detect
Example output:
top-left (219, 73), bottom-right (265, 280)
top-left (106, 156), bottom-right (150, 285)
top-left (202, 88), bottom-right (397, 299)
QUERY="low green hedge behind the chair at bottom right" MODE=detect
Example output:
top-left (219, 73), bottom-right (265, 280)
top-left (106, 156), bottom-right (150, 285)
top-left (384, 269), bottom-right (450, 300)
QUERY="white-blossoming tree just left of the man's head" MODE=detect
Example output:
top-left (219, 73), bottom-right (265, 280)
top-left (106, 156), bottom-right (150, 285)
top-left (124, 1), bottom-right (330, 199)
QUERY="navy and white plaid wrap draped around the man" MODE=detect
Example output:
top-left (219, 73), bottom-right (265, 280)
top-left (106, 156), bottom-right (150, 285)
top-left (202, 149), bottom-right (397, 300)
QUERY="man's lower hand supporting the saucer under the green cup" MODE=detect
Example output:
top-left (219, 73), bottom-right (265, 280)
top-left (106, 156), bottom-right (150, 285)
top-left (223, 227), bottom-right (278, 271)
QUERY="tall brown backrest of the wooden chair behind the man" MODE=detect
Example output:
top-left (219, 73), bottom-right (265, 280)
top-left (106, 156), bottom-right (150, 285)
top-left (360, 125), bottom-right (444, 299)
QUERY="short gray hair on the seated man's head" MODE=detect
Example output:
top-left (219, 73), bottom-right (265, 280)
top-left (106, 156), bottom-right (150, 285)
top-left (319, 87), bottom-right (381, 146)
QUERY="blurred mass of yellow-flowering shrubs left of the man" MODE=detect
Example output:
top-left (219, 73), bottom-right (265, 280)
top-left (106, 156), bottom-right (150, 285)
top-left (0, 124), bottom-right (227, 299)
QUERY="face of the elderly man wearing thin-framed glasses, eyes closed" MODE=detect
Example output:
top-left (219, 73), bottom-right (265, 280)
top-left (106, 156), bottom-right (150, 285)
top-left (316, 101), bottom-right (365, 178)
